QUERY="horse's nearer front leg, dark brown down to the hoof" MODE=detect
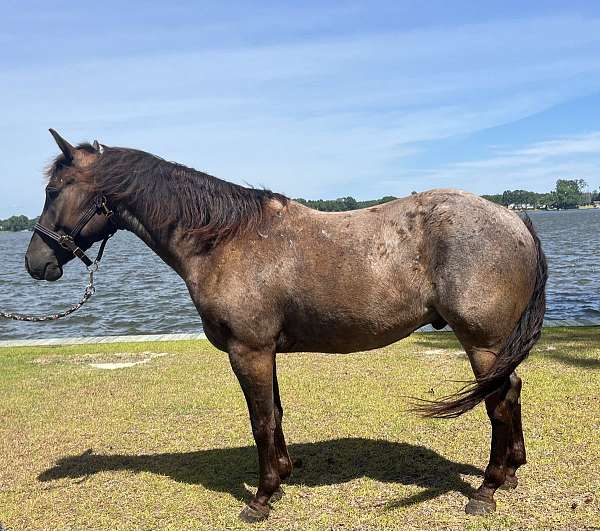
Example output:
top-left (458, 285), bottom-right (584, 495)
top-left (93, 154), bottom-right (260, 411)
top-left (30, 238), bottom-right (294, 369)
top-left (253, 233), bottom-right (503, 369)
top-left (229, 344), bottom-right (280, 522)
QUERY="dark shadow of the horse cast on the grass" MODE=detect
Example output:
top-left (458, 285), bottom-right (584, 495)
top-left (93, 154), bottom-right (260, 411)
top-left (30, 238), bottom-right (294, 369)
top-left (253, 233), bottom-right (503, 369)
top-left (38, 438), bottom-right (482, 506)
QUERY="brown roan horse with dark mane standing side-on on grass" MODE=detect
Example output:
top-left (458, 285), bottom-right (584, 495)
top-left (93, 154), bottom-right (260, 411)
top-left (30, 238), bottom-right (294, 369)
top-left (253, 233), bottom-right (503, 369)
top-left (25, 129), bottom-right (547, 522)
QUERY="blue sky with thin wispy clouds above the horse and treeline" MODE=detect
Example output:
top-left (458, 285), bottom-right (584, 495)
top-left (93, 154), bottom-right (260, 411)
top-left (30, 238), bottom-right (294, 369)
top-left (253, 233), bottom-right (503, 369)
top-left (0, 0), bottom-right (600, 218)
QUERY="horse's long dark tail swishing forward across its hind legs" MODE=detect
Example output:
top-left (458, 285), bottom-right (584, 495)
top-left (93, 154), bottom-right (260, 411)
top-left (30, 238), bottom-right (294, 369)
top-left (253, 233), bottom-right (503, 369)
top-left (415, 216), bottom-right (548, 418)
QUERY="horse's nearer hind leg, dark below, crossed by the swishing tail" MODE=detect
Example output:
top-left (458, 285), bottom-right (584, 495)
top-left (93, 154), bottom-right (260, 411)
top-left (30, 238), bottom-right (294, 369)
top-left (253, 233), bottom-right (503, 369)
top-left (465, 348), bottom-right (513, 514)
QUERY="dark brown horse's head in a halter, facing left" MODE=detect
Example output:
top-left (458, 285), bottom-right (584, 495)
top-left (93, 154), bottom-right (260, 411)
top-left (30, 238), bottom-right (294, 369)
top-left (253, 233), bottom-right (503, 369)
top-left (25, 129), bottom-right (114, 281)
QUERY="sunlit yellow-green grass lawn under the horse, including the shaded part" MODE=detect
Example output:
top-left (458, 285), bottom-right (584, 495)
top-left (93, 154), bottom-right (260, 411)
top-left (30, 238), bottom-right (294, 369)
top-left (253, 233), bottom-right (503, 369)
top-left (0, 328), bottom-right (600, 530)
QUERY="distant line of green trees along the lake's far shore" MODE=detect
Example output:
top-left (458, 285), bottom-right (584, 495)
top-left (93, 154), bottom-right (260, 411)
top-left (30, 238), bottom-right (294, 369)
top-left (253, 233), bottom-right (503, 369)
top-left (0, 179), bottom-right (600, 232)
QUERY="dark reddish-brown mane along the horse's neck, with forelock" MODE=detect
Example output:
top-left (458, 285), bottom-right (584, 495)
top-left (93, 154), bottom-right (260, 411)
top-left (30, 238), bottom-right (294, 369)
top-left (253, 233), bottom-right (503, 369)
top-left (48, 143), bottom-right (288, 244)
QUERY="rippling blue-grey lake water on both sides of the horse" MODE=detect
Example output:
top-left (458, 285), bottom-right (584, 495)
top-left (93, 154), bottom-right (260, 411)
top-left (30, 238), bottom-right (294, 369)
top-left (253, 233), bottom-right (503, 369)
top-left (0, 209), bottom-right (600, 340)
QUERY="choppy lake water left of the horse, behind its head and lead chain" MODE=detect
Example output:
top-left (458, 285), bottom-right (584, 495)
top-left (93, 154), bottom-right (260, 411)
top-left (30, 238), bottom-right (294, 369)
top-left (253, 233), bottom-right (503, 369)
top-left (0, 231), bottom-right (202, 340)
